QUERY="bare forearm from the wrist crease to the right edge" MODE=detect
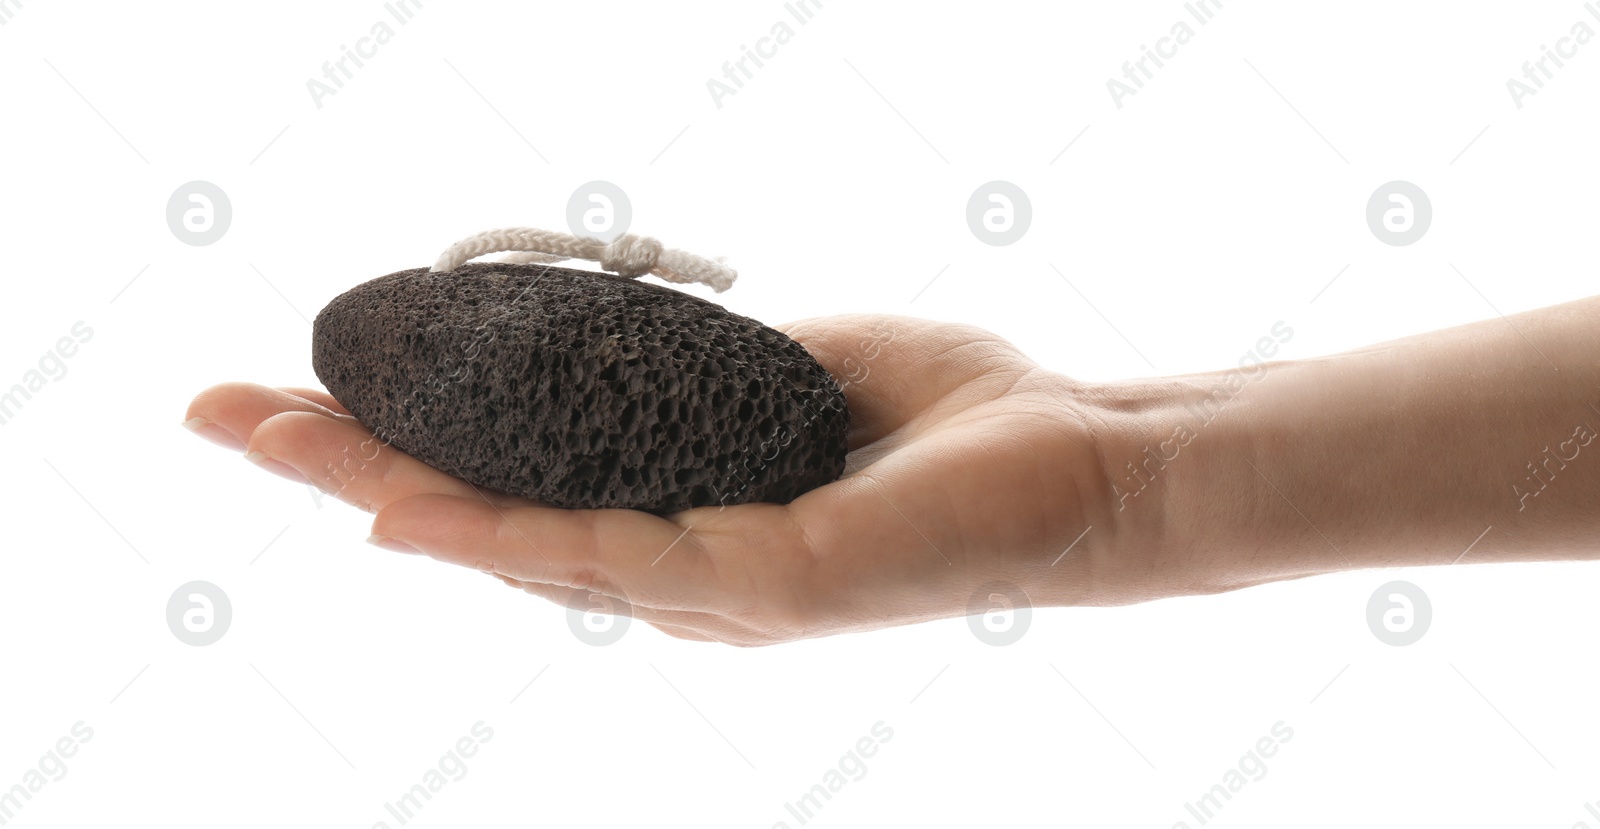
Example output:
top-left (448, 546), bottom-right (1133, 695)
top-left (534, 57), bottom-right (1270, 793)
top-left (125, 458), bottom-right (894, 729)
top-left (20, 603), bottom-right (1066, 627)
top-left (1099, 298), bottom-right (1600, 600)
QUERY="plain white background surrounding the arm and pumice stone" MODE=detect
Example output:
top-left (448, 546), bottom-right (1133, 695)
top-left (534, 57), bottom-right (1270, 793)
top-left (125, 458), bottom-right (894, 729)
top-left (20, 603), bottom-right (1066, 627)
top-left (0, 0), bottom-right (1600, 827)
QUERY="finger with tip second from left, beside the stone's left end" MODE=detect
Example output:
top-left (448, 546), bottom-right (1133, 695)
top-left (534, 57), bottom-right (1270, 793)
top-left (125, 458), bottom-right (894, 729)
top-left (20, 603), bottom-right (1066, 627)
top-left (246, 411), bottom-right (531, 512)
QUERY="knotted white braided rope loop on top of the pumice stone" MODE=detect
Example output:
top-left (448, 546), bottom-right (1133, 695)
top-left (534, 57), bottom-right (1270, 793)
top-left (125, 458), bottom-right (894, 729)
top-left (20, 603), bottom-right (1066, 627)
top-left (432, 227), bottom-right (739, 293)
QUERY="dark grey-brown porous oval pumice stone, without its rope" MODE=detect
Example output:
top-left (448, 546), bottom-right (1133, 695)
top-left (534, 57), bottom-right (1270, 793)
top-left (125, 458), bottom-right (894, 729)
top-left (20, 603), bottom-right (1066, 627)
top-left (312, 262), bottom-right (850, 512)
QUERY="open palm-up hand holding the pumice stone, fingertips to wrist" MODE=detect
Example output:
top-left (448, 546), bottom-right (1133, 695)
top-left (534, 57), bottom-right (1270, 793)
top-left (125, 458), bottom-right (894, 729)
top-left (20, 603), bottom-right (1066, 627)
top-left (189, 315), bottom-right (1110, 645)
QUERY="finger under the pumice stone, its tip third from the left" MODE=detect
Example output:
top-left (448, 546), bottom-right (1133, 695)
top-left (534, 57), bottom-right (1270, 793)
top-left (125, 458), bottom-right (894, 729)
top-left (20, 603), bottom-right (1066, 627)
top-left (373, 495), bottom-right (722, 611)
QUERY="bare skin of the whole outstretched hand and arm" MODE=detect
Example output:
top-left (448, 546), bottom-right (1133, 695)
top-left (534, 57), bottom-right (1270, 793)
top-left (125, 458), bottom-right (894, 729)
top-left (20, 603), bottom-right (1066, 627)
top-left (187, 298), bottom-right (1600, 645)
